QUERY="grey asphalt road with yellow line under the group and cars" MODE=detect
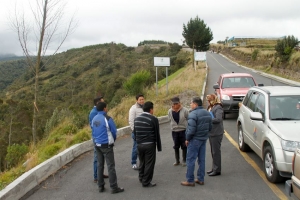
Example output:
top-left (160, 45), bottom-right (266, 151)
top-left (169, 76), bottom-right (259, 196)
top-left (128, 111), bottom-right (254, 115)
top-left (23, 53), bottom-right (287, 200)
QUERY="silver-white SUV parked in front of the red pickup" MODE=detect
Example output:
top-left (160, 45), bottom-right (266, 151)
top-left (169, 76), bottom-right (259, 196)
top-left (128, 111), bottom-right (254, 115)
top-left (237, 86), bottom-right (300, 183)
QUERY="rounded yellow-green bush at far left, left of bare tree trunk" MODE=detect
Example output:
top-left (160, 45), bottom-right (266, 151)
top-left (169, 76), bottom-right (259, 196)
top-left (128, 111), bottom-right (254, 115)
top-left (5, 144), bottom-right (28, 168)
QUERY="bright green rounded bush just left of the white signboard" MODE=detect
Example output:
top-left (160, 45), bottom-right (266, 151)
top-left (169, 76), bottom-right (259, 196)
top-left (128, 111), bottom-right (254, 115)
top-left (123, 70), bottom-right (150, 95)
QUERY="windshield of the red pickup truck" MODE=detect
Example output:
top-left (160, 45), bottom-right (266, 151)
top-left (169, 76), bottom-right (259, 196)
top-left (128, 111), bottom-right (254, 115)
top-left (222, 77), bottom-right (255, 88)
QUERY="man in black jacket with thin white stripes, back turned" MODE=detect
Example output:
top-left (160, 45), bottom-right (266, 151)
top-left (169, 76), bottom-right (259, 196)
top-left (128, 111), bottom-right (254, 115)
top-left (133, 101), bottom-right (161, 187)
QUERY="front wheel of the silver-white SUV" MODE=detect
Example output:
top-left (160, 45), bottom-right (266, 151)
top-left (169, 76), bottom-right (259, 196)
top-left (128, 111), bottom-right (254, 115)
top-left (263, 146), bottom-right (283, 183)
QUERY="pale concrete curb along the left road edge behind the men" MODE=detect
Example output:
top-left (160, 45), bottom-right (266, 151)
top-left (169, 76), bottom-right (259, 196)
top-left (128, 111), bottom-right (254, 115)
top-left (0, 116), bottom-right (169, 200)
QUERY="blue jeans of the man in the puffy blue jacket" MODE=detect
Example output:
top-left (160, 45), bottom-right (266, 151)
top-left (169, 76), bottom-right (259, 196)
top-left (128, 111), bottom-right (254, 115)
top-left (186, 139), bottom-right (206, 183)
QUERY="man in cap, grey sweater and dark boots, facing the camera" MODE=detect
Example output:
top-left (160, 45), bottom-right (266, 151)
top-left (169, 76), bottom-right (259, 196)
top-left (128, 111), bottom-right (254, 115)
top-left (168, 97), bottom-right (189, 166)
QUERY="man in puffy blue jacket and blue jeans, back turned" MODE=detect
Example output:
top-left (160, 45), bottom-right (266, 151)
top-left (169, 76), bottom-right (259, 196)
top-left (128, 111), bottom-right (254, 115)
top-left (181, 97), bottom-right (212, 186)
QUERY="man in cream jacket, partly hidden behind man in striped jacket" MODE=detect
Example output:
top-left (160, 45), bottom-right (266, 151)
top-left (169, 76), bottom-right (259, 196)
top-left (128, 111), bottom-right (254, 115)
top-left (128, 94), bottom-right (145, 170)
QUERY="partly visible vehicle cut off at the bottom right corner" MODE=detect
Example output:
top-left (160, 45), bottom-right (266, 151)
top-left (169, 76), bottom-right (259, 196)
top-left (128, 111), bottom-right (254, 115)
top-left (285, 148), bottom-right (300, 199)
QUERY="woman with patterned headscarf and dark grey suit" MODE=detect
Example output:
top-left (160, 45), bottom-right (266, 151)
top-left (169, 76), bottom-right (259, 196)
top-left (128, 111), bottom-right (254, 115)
top-left (206, 94), bottom-right (224, 176)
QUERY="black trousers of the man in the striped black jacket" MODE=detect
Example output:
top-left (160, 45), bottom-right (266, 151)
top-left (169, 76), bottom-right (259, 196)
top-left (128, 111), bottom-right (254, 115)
top-left (137, 143), bottom-right (156, 186)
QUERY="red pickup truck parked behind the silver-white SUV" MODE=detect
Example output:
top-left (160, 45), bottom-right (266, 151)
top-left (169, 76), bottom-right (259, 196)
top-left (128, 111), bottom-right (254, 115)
top-left (213, 72), bottom-right (257, 119)
